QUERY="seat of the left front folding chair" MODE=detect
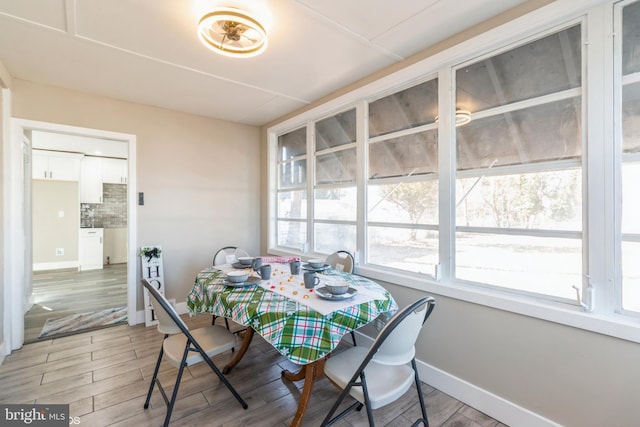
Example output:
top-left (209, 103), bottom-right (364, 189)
top-left (163, 325), bottom-right (236, 367)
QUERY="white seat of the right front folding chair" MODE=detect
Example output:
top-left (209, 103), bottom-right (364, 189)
top-left (324, 346), bottom-right (414, 409)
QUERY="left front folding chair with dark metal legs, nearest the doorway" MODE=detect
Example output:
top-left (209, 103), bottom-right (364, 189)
top-left (142, 279), bottom-right (247, 427)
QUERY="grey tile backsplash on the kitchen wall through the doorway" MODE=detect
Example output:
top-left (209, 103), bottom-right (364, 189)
top-left (80, 184), bottom-right (127, 228)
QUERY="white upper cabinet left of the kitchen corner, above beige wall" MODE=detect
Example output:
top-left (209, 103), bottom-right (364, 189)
top-left (31, 150), bottom-right (82, 181)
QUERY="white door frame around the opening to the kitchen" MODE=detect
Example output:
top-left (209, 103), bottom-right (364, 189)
top-left (4, 118), bottom-right (138, 351)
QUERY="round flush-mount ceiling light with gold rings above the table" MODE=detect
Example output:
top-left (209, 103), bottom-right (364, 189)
top-left (198, 8), bottom-right (267, 58)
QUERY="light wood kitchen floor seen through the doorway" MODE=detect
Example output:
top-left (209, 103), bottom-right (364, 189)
top-left (24, 264), bottom-right (127, 343)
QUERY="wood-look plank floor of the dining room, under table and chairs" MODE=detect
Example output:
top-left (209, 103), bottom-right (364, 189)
top-left (0, 315), bottom-right (504, 427)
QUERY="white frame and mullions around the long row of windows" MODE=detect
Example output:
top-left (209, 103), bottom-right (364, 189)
top-left (266, 0), bottom-right (640, 342)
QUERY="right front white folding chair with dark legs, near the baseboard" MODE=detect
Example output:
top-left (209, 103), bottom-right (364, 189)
top-left (322, 297), bottom-right (435, 427)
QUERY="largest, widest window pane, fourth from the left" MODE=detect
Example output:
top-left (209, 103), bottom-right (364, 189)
top-left (455, 25), bottom-right (582, 300)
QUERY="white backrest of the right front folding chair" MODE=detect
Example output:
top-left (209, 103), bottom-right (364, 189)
top-left (370, 297), bottom-right (436, 365)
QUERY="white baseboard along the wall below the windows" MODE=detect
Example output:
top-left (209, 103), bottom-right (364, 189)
top-left (356, 331), bottom-right (561, 427)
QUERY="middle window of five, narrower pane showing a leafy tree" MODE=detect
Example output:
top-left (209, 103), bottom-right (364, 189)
top-left (366, 79), bottom-right (439, 275)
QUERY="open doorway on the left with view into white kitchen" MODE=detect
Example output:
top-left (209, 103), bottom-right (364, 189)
top-left (25, 130), bottom-right (128, 343)
